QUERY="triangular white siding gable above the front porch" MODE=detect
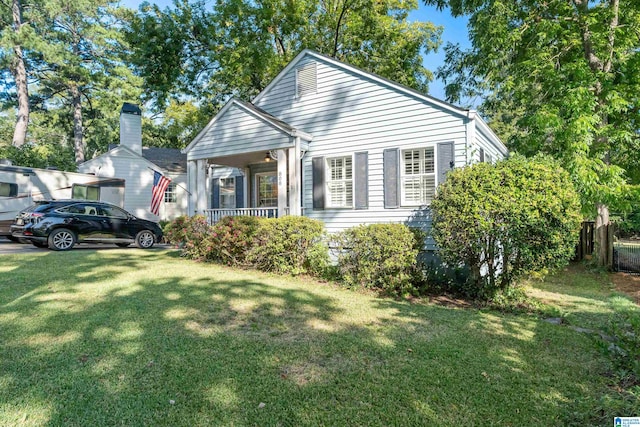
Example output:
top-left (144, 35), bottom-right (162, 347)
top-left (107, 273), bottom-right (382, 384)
top-left (188, 105), bottom-right (293, 160)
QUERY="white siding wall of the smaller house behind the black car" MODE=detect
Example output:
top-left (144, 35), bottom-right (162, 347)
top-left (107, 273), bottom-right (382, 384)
top-left (78, 151), bottom-right (187, 221)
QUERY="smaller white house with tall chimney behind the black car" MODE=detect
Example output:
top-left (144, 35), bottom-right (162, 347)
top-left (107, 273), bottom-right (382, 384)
top-left (78, 103), bottom-right (187, 220)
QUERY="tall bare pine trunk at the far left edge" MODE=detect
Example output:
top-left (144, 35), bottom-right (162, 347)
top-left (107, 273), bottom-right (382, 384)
top-left (10, 0), bottom-right (29, 147)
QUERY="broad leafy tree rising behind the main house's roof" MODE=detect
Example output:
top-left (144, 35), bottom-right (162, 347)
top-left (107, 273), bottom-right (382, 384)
top-left (128, 0), bottom-right (441, 146)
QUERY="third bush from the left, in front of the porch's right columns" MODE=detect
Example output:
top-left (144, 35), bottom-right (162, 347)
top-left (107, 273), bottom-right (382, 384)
top-left (249, 216), bottom-right (328, 275)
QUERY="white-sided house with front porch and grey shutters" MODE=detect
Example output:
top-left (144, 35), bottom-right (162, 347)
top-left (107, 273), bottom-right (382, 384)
top-left (183, 50), bottom-right (507, 249)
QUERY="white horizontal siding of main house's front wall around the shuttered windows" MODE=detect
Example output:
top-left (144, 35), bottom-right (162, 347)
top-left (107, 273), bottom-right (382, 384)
top-left (256, 56), bottom-right (467, 239)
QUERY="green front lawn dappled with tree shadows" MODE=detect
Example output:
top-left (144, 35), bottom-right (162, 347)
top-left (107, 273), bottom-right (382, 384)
top-left (0, 249), bottom-right (640, 426)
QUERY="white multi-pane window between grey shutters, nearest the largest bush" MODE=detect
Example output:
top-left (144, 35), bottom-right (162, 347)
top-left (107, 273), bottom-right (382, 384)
top-left (401, 147), bottom-right (436, 205)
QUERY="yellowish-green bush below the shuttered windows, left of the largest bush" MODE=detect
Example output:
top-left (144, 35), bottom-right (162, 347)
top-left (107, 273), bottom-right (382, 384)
top-left (336, 224), bottom-right (418, 294)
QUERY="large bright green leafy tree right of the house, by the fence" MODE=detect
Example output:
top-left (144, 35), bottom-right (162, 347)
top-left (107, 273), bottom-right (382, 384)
top-left (426, 0), bottom-right (640, 262)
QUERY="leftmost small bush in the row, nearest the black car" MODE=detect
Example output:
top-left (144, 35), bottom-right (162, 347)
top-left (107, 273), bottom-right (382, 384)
top-left (164, 215), bottom-right (211, 259)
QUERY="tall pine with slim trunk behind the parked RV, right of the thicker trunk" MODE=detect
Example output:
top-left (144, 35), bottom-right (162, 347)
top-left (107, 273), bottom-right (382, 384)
top-left (35, 0), bottom-right (140, 164)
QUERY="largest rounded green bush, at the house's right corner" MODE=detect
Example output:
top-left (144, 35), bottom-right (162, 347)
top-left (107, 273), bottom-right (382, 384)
top-left (431, 156), bottom-right (581, 299)
